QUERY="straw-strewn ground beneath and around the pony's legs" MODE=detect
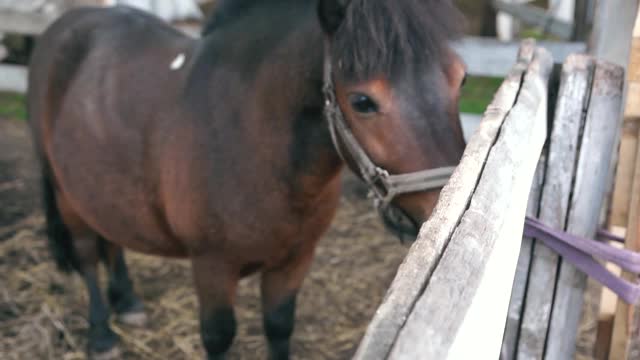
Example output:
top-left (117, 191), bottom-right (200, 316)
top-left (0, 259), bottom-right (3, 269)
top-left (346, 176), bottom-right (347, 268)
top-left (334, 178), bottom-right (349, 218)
top-left (0, 119), bottom-right (407, 360)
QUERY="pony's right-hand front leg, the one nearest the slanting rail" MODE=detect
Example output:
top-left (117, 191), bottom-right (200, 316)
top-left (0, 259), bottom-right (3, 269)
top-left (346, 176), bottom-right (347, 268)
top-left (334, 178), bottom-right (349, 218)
top-left (261, 250), bottom-right (313, 360)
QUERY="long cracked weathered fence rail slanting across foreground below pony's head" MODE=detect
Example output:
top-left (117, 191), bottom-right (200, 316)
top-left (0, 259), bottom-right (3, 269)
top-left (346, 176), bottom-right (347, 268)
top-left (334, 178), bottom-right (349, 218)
top-left (355, 41), bottom-right (552, 359)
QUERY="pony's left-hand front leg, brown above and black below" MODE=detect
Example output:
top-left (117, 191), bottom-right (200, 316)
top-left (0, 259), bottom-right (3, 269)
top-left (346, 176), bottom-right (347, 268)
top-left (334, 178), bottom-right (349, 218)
top-left (192, 256), bottom-right (238, 360)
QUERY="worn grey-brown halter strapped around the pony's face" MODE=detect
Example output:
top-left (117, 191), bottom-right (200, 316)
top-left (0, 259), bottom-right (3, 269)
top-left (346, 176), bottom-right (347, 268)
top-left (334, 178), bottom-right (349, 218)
top-left (322, 40), bottom-right (455, 209)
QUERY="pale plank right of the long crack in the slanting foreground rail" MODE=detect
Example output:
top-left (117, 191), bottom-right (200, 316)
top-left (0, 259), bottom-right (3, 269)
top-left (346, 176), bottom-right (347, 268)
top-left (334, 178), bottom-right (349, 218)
top-left (389, 48), bottom-right (553, 359)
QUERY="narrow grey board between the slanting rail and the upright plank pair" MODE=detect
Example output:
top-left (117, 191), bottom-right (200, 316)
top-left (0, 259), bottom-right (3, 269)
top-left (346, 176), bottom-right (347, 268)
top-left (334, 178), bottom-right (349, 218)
top-left (501, 154), bottom-right (547, 359)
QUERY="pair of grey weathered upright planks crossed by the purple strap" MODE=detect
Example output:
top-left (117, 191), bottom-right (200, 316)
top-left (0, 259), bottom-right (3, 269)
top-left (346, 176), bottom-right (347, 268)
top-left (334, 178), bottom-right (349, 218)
top-left (503, 55), bottom-right (624, 359)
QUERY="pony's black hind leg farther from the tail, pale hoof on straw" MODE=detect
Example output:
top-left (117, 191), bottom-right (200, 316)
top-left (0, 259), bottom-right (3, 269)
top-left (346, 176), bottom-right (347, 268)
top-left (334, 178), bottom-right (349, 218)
top-left (101, 239), bottom-right (148, 326)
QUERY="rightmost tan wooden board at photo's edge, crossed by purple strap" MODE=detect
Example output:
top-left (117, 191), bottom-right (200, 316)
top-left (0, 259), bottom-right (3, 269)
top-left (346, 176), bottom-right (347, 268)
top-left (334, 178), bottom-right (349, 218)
top-left (609, 133), bottom-right (640, 360)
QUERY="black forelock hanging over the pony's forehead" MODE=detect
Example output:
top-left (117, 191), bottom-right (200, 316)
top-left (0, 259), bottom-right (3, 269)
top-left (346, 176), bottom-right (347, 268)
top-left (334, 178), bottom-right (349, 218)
top-left (331, 0), bottom-right (464, 80)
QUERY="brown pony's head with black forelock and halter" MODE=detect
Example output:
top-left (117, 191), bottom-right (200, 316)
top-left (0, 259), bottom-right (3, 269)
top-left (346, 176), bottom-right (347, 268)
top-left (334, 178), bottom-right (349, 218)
top-left (318, 0), bottom-right (465, 242)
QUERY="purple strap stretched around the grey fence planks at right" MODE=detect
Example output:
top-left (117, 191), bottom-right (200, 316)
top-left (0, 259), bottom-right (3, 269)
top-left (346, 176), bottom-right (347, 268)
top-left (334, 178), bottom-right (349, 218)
top-left (524, 217), bottom-right (640, 304)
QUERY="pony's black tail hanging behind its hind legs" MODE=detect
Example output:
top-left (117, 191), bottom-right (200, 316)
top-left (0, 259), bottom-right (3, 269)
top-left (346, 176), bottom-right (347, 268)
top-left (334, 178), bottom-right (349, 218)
top-left (42, 170), bottom-right (79, 273)
